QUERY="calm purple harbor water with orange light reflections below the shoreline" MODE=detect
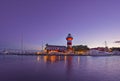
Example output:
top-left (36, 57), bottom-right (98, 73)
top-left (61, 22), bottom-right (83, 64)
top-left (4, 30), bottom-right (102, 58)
top-left (0, 55), bottom-right (120, 81)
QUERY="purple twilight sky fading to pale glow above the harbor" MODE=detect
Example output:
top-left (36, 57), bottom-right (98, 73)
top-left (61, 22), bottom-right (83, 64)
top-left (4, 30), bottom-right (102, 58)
top-left (0, 0), bottom-right (120, 49)
